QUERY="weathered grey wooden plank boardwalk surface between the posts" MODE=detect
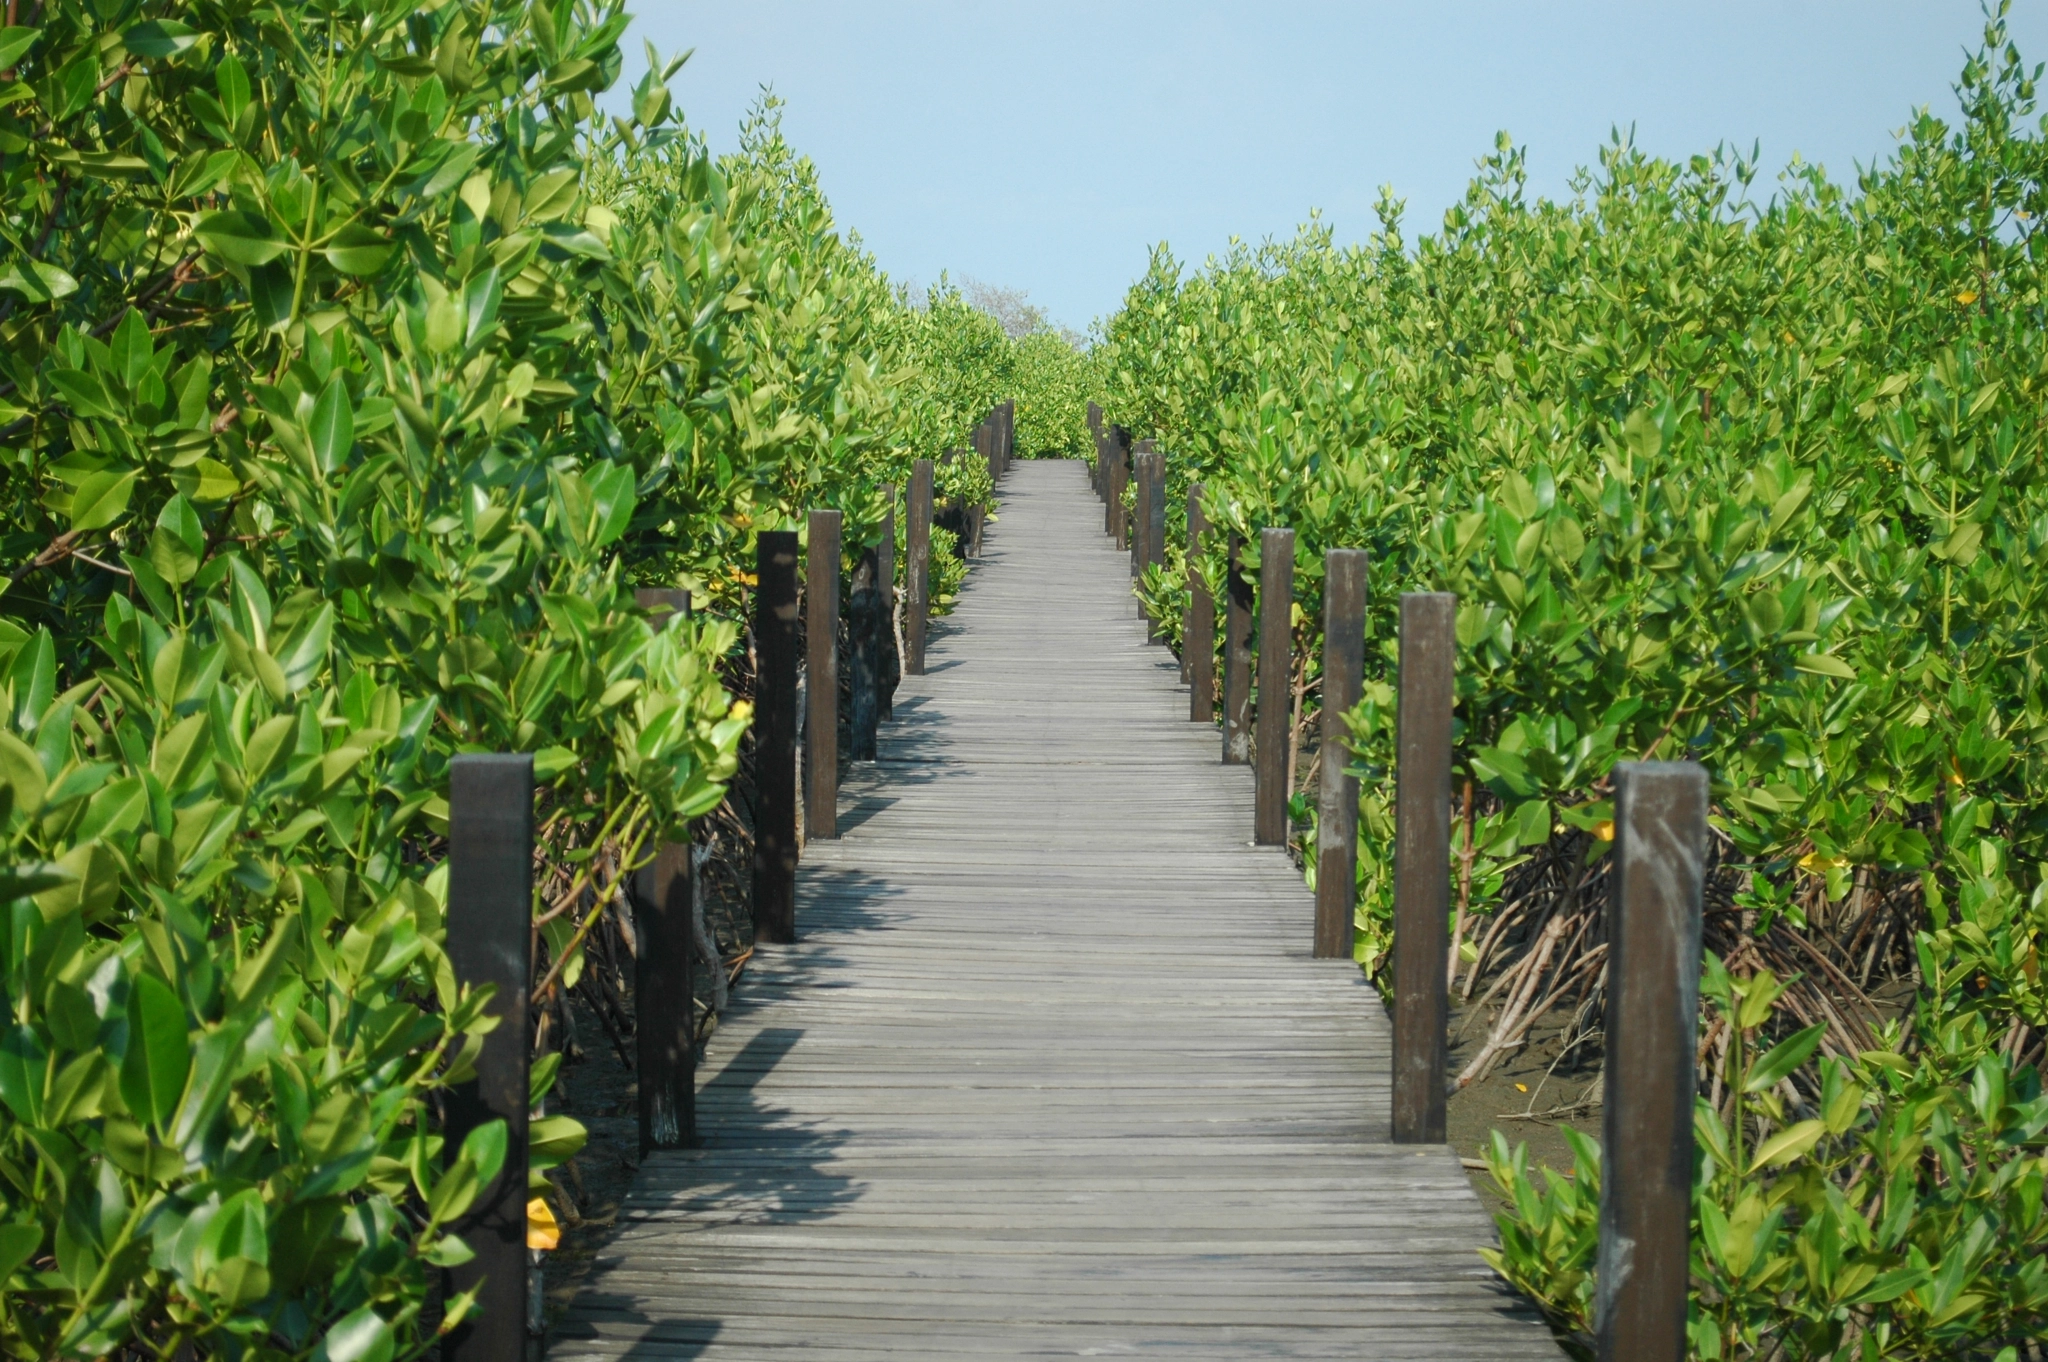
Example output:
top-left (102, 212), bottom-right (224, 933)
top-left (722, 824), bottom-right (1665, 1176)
top-left (549, 463), bottom-right (1561, 1362)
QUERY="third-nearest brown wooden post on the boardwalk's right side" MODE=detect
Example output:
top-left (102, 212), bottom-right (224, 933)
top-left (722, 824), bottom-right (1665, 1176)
top-left (1315, 549), bottom-right (1366, 961)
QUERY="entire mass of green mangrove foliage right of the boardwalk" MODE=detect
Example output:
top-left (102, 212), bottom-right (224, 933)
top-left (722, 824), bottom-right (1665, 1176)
top-left (1100, 8), bottom-right (2048, 1358)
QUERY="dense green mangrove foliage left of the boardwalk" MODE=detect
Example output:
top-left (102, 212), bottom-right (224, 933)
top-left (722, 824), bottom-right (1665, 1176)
top-left (0, 0), bottom-right (995, 1358)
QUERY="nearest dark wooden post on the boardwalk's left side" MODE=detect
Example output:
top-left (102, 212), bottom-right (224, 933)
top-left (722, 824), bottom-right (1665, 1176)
top-left (442, 754), bottom-right (532, 1362)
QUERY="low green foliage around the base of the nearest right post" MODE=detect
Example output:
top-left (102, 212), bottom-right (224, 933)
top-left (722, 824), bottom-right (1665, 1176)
top-left (1483, 876), bottom-right (2048, 1362)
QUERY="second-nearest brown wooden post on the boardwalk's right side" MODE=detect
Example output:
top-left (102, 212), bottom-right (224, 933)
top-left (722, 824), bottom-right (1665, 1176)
top-left (1395, 592), bottom-right (1458, 1145)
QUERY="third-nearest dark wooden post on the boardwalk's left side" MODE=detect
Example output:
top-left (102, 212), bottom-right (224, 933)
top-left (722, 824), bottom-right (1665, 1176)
top-left (754, 530), bottom-right (797, 944)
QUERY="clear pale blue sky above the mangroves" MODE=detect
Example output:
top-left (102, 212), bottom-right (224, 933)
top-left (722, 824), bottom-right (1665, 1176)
top-left (606, 0), bottom-right (2048, 330)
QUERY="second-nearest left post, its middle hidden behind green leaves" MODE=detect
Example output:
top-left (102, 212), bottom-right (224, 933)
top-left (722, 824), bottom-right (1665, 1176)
top-left (633, 586), bottom-right (696, 1159)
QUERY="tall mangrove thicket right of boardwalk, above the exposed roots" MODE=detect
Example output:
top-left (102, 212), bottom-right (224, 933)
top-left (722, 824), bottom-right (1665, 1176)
top-left (1104, 7), bottom-right (2048, 966)
